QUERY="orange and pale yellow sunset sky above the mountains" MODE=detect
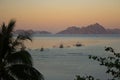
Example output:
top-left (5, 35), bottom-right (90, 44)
top-left (0, 0), bottom-right (120, 33)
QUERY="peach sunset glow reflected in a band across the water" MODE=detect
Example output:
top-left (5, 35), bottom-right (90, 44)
top-left (26, 34), bottom-right (119, 49)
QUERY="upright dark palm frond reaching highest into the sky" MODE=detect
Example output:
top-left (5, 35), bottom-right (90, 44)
top-left (0, 20), bottom-right (15, 58)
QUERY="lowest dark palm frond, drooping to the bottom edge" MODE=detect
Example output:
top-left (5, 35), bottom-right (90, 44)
top-left (7, 64), bottom-right (44, 80)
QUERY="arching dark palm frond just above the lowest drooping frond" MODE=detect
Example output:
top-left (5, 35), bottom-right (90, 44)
top-left (5, 50), bottom-right (32, 66)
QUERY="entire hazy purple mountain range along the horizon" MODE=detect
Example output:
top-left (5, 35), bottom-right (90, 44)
top-left (14, 23), bottom-right (120, 34)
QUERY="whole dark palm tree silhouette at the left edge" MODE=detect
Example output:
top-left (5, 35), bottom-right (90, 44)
top-left (0, 20), bottom-right (44, 80)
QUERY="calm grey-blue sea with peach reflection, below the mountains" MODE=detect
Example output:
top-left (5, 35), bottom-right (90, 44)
top-left (26, 34), bottom-right (120, 80)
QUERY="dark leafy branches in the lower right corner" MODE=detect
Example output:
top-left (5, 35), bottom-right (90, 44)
top-left (75, 47), bottom-right (120, 80)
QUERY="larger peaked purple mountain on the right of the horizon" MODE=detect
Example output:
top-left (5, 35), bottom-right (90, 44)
top-left (57, 23), bottom-right (120, 34)
